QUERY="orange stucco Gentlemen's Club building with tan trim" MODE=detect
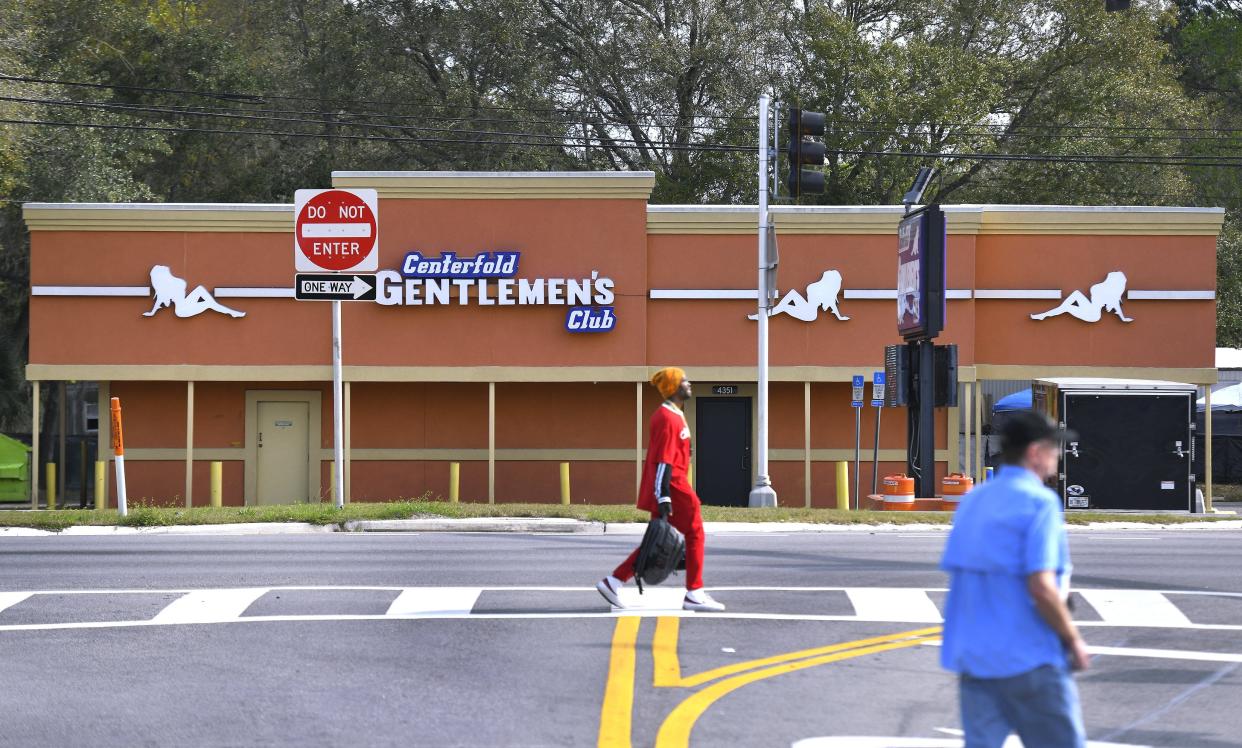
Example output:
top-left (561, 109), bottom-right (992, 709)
top-left (25, 171), bottom-right (1223, 506)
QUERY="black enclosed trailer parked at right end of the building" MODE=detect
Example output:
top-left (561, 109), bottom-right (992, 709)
top-left (1032, 379), bottom-right (1196, 512)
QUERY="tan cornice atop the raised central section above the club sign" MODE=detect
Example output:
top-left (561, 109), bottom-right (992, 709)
top-left (332, 171), bottom-right (656, 200)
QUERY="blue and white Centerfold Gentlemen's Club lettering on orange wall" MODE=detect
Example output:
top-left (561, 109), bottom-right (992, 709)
top-left (375, 251), bottom-right (617, 333)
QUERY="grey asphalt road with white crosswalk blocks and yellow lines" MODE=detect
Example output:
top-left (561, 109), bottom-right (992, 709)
top-left (0, 531), bottom-right (1242, 748)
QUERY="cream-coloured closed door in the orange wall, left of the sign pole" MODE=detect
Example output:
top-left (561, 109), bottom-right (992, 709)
top-left (257, 400), bottom-right (311, 504)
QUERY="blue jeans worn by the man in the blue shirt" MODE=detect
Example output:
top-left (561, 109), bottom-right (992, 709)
top-left (959, 665), bottom-right (1087, 748)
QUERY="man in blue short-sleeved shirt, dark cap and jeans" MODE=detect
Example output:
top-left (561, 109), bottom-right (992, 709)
top-left (940, 411), bottom-right (1089, 748)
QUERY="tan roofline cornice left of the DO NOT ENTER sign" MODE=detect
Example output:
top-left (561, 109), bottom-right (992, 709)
top-left (21, 203), bottom-right (293, 234)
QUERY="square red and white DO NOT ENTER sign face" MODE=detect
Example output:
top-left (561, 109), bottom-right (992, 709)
top-left (293, 190), bottom-right (380, 272)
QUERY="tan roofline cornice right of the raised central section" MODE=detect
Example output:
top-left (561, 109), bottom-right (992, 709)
top-left (647, 205), bottom-right (1225, 237)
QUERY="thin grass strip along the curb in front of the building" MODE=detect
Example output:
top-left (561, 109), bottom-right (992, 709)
top-left (0, 498), bottom-right (1233, 531)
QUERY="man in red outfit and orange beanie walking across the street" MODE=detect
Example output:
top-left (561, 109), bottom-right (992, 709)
top-left (595, 367), bottom-right (724, 611)
